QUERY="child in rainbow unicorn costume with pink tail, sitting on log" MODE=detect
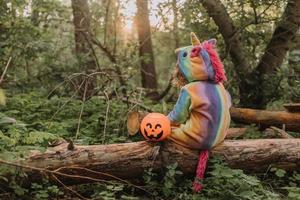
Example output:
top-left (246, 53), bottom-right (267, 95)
top-left (168, 33), bottom-right (231, 191)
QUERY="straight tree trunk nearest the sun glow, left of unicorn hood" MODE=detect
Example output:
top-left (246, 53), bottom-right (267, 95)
top-left (136, 0), bottom-right (157, 98)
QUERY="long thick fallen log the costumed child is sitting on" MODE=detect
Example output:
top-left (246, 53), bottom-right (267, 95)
top-left (0, 139), bottom-right (300, 184)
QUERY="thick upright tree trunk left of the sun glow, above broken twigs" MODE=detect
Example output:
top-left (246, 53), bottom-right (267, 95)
top-left (71, 0), bottom-right (97, 100)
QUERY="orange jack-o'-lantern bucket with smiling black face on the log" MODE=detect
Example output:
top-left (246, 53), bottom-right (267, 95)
top-left (141, 113), bottom-right (171, 141)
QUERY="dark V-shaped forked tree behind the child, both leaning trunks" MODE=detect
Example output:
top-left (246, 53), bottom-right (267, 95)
top-left (199, 0), bottom-right (300, 108)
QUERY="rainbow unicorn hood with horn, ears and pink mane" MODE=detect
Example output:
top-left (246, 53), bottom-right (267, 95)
top-left (175, 33), bottom-right (226, 83)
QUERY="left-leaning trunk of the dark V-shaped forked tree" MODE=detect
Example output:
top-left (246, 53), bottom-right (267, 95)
top-left (200, 0), bottom-right (256, 107)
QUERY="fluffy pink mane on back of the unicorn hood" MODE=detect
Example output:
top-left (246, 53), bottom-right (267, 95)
top-left (202, 41), bottom-right (227, 83)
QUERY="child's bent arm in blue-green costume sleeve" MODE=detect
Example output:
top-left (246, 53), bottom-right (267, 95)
top-left (168, 88), bottom-right (191, 126)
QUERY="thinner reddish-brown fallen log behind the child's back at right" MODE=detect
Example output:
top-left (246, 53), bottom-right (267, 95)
top-left (230, 107), bottom-right (300, 131)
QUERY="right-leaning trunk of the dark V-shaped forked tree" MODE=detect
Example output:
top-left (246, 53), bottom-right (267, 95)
top-left (253, 0), bottom-right (300, 108)
